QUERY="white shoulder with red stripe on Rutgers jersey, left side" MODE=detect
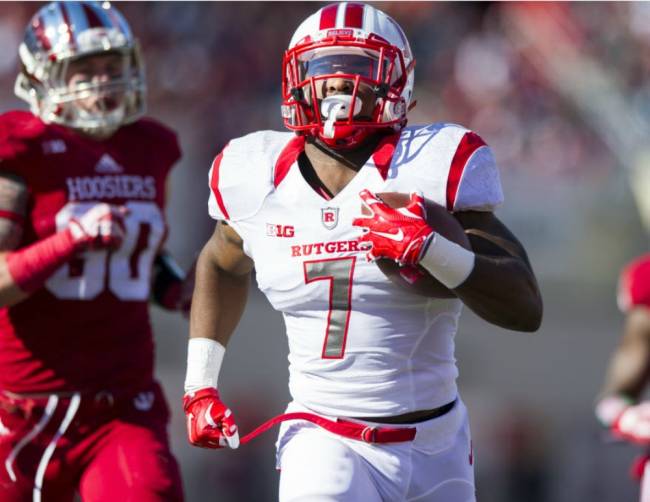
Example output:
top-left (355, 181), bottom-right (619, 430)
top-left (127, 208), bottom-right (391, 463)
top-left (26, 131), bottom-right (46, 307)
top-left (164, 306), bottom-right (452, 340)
top-left (208, 131), bottom-right (296, 221)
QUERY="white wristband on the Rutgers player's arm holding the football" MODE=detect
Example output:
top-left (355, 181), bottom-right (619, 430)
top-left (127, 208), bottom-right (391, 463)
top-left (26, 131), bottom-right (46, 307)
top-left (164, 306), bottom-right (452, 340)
top-left (420, 233), bottom-right (476, 289)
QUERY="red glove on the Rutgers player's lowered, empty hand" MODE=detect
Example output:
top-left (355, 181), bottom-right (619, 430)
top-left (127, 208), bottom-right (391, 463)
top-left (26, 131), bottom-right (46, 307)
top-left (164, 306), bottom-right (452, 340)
top-left (183, 387), bottom-right (239, 449)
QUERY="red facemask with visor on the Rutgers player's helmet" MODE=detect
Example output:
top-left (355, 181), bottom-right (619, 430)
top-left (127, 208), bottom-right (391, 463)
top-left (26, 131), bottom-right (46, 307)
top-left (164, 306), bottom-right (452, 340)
top-left (282, 39), bottom-right (408, 149)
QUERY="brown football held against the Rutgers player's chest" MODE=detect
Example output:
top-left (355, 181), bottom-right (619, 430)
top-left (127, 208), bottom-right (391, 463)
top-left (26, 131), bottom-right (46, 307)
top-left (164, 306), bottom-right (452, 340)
top-left (361, 192), bottom-right (471, 298)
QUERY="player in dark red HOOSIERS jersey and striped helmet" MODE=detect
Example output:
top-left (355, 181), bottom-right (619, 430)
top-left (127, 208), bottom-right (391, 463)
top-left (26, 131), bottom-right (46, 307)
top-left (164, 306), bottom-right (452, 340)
top-left (0, 2), bottom-right (189, 502)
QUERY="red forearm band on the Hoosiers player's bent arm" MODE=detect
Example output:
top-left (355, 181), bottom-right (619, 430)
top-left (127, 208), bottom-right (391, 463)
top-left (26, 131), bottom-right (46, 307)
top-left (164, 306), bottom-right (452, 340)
top-left (7, 229), bottom-right (77, 293)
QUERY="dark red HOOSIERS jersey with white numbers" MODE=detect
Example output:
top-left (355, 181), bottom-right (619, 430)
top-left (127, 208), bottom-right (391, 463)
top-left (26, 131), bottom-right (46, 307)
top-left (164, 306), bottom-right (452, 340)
top-left (0, 112), bottom-right (180, 393)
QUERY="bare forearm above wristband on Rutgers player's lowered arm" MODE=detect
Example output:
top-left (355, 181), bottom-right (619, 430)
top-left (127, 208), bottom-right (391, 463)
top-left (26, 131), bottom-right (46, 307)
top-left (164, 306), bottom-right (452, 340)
top-left (190, 242), bottom-right (250, 347)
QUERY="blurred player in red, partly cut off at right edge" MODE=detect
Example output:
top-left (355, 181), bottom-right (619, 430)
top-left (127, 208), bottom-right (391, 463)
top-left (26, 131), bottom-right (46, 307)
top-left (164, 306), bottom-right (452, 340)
top-left (596, 254), bottom-right (650, 501)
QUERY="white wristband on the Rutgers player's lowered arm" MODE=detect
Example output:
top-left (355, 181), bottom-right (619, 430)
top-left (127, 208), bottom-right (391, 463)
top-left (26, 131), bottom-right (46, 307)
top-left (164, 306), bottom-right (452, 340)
top-left (185, 338), bottom-right (226, 392)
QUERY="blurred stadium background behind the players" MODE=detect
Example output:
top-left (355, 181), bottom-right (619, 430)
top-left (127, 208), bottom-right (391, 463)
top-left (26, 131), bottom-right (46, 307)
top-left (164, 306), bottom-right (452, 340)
top-left (0, 2), bottom-right (650, 502)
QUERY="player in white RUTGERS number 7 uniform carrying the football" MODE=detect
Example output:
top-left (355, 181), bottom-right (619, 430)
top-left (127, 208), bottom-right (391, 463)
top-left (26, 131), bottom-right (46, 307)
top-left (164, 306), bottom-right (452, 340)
top-left (184, 3), bottom-right (542, 502)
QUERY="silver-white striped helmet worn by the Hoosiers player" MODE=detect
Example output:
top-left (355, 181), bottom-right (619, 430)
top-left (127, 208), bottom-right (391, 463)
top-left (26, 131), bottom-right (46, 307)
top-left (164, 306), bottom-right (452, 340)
top-left (14, 2), bottom-right (145, 137)
